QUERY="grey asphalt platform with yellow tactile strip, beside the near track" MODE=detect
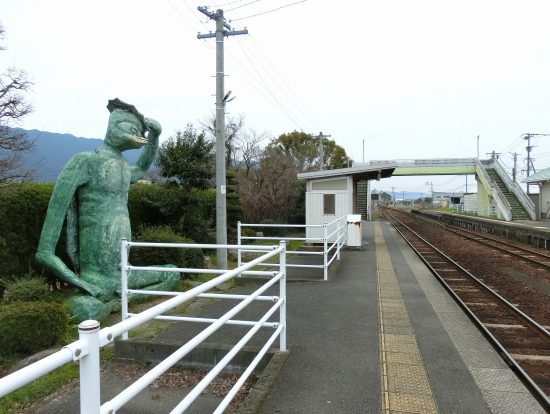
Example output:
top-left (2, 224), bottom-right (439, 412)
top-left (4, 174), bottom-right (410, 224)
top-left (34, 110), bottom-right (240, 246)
top-left (24, 221), bottom-right (544, 414)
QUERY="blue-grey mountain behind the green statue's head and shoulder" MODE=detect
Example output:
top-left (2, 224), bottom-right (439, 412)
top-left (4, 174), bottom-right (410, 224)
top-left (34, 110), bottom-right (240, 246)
top-left (14, 128), bottom-right (139, 182)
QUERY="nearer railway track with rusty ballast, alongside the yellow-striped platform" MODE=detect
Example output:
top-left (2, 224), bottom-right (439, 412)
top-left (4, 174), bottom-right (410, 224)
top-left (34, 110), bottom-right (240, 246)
top-left (383, 209), bottom-right (550, 412)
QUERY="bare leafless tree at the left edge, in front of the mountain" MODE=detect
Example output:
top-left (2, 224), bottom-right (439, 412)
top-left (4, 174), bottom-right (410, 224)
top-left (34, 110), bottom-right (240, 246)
top-left (0, 24), bottom-right (34, 189)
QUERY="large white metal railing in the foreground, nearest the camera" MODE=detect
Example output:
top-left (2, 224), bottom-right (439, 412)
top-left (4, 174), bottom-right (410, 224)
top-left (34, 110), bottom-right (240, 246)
top-left (0, 240), bottom-right (286, 414)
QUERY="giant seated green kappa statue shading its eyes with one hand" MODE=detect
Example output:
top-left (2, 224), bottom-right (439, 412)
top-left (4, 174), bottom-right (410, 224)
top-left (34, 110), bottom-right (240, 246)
top-left (36, 98), bottom-right (180, 321)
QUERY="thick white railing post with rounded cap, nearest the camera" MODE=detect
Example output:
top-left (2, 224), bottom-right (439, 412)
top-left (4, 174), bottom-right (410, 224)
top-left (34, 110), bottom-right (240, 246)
top-left (78, 320), bottom-right (101, 414)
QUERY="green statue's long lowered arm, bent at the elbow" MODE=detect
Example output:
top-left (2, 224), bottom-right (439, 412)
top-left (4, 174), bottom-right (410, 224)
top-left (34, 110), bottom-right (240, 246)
top-left (35, 154), bottom-right (101, 296)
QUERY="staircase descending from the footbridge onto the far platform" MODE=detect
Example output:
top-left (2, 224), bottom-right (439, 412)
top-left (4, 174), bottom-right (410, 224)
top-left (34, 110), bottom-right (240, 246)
top-left (480, 159), bottom-right (536, 220)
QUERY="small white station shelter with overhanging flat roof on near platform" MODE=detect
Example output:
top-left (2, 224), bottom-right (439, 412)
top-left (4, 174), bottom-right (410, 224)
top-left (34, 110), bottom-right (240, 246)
top-left (298, 163), bottom-right (396, 241)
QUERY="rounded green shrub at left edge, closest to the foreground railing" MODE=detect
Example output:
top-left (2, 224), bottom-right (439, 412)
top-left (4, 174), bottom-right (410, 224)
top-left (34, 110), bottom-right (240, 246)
top-left (0, 302), bottom-right (68, 357)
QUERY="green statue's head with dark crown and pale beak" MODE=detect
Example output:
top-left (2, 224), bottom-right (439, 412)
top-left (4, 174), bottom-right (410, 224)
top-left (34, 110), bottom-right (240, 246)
top-left (105, 98), bottom-right (149, 151)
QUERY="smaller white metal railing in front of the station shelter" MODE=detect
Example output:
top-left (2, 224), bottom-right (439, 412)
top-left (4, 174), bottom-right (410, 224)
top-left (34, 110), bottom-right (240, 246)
top-left (237, 216), bottom-right (347, 280)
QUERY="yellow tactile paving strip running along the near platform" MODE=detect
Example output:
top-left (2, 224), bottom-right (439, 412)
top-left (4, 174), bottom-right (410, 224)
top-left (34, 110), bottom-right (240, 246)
top-left (374, 223), bottom-right (438, 414)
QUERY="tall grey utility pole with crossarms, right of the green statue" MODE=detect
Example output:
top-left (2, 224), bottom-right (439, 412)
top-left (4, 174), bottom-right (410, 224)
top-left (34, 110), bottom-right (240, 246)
top-left (197, 6), bottom-right (248, 269)
